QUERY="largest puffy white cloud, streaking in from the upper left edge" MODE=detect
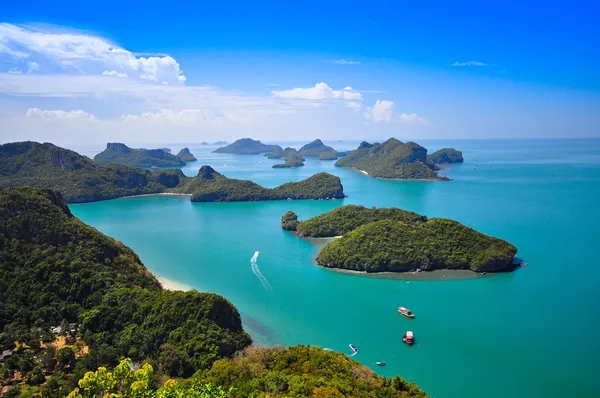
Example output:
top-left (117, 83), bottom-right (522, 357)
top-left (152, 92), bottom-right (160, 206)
top-left (0, 23), bottom-right (186, 84)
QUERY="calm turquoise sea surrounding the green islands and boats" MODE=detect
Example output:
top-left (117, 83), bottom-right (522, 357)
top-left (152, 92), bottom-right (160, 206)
top-left (70, 140), bottom-right (600, 398)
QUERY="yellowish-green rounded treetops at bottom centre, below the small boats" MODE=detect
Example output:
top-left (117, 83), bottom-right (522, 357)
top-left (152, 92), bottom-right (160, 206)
top-left (194, 345), bottom-right (427, 398)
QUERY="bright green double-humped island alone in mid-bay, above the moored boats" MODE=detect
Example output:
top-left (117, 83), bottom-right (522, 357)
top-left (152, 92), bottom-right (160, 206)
top-left (281, 205), bottom-right (517, 272)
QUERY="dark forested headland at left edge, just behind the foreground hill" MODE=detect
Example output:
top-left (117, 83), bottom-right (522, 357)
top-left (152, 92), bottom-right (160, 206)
top-left (0, 142), bottom-right (178, 203)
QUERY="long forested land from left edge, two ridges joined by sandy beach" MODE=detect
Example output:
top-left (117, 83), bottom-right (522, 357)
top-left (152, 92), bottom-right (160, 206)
top-left (0, 142), bottom-right (344, 203)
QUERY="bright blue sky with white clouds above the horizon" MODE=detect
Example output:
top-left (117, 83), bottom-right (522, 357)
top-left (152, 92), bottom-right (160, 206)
top-left (0, 1), bottom-right (600, 143)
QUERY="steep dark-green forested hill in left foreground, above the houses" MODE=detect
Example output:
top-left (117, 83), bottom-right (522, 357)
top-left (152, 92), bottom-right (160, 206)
top-left (0, 187), bottom-right (251, 396)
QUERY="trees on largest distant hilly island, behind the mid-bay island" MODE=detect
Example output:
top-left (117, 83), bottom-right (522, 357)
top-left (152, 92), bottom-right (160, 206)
top-left (335, 138), bottom-right (447, 180)
